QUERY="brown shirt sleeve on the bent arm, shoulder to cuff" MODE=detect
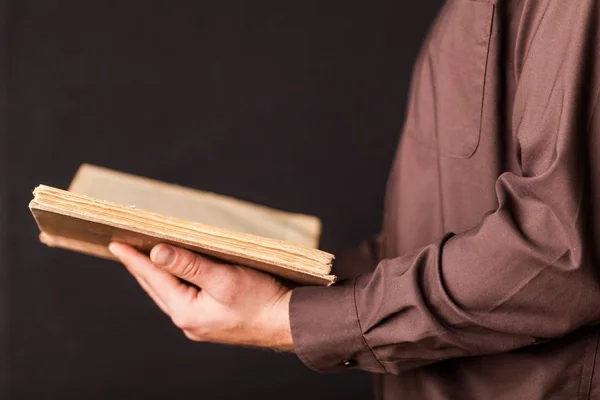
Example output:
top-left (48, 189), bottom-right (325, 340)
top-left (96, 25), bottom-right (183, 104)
top-left (290, 0), bottom-right (600, 373)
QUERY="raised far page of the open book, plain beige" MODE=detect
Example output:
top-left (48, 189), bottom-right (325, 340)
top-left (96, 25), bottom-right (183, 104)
top-left (69, 164), bottom-right (321, 248)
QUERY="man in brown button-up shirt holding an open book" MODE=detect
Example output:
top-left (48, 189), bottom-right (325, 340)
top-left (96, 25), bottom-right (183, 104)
top-left (111, 0), bottom-right (600, 399)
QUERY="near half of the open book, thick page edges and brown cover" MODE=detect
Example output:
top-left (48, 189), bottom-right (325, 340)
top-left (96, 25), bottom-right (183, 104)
top-left (29, 185), bottom-right (336, 285)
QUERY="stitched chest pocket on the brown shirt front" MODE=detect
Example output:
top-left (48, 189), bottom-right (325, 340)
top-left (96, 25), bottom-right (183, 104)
top-left (405, 0), bottom-right (494, 158)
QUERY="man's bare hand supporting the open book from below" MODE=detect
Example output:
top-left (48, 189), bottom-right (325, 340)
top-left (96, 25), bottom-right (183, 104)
top-left (109, 243), bottom-right (293, 351)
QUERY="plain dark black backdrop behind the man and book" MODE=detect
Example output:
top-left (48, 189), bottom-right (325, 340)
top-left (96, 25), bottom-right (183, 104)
top-left (0, 0), bottom-right (440, 399)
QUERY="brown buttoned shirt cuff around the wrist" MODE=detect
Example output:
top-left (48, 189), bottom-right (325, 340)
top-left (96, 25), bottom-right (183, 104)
top-left (290, 278), bottom-right (385, 373)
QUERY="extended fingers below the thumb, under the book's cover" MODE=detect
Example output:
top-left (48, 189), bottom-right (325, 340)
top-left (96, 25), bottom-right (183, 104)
top-left (108, 242), bottom-right (189, 313)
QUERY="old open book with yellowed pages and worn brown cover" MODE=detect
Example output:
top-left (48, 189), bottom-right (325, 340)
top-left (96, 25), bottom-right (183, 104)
top-left (29, 164), bottom-right (336, 285)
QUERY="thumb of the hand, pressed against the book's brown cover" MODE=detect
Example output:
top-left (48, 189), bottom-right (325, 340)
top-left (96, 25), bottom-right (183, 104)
top-left (150, 244), bottom-right (235, 293)
